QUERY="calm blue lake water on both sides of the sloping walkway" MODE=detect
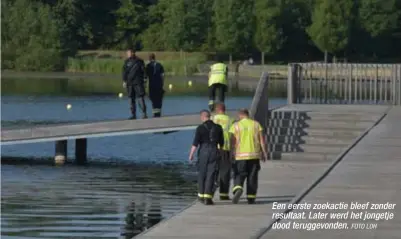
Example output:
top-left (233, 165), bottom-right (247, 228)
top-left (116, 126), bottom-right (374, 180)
top-left (1, 96), bottom-right (285, 238)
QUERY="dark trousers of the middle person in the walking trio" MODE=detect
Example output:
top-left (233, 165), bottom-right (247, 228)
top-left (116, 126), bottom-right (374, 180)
top-left (219, 150), bottom-right (232, 197)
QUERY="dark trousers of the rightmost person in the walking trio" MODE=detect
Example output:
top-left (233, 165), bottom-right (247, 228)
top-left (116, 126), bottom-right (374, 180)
top-left (233, 159), bottom-right (260, 200)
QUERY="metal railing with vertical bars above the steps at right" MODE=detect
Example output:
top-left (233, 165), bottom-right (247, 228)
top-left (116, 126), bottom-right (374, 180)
top-left (287, 63), bottom-right (401, 105)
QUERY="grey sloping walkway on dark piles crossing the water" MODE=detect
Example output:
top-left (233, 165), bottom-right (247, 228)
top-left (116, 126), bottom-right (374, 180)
top-left (1, 111), bottom-right (235, 145)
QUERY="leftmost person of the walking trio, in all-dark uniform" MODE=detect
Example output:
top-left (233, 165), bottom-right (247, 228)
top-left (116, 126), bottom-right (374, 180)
top-left (189, 110), bottom-right (224, 205)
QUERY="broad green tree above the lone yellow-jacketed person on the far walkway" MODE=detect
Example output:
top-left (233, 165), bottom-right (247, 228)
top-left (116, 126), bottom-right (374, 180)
top-left (213, 0), bottom-right (254, 60)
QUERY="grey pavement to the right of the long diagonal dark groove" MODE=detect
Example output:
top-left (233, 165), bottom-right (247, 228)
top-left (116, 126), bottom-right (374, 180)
top-left (262, 107), bottom-right (401, 239)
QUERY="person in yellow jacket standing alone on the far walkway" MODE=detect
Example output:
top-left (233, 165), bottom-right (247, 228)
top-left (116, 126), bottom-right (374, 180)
top-left (208, 62), bottom-right (228, 111)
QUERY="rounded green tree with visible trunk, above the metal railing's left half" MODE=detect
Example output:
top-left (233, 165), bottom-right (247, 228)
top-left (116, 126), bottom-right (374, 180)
top-left (307, 0), bottom-right (354, 60)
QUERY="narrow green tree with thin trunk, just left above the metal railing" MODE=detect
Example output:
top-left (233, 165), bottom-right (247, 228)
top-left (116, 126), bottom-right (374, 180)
top-left (254, 0), bottom-right (285, 64)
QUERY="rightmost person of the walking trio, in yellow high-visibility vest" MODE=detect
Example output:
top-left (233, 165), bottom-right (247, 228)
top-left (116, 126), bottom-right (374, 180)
top-left (230, 109), bottom-right (267, 204)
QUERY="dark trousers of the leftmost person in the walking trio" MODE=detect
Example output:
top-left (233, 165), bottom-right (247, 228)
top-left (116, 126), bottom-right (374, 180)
top-left (198, 146), bottom-right (219, 199)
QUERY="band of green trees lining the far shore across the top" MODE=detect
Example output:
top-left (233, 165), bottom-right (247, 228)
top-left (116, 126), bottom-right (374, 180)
top-left (1, 0), bottom-right (401, 70)
